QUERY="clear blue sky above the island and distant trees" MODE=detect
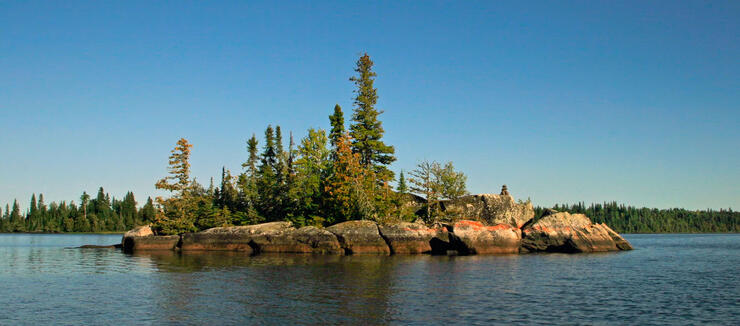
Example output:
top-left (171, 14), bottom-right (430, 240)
top-left (0, 1), bottom-right (740, 209)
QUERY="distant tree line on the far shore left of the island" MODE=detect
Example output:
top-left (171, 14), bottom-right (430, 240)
top-left (0, 187), bottom-right (156, 233)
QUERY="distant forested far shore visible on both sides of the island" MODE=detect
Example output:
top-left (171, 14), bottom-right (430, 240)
top-left (0, 191), bottom-right (740, 233)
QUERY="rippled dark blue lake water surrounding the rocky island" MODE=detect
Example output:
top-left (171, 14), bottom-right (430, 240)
top-left (0, 234), bottom-right (740, 325)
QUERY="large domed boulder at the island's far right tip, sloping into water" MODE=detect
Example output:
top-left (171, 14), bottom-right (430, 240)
top-left (522, 212), bottom-right (632, 252)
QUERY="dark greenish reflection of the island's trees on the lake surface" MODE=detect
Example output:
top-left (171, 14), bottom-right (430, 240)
top-left (133, 251), bottom-right (398, 324)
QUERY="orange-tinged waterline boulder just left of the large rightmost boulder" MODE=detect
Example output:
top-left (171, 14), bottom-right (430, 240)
top-left (449, 220), bottom-right (522, 255)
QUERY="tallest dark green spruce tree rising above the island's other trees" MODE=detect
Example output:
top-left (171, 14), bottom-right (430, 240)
top-left (350, 53), bottom-right (396, 183)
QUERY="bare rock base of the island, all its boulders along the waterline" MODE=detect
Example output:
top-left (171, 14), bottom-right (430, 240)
top-left (121, 189), bottom-right (632, 255)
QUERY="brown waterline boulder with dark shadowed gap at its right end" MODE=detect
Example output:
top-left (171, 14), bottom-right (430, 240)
top-left (378, 222), bottom-right (450, 254)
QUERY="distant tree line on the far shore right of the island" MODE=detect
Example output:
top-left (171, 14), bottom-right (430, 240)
top-left (535, 202), bottom-right (740, 233)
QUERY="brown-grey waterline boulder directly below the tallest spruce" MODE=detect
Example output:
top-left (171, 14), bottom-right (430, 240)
top-left (326, 221), bottom-right (391, 255)
